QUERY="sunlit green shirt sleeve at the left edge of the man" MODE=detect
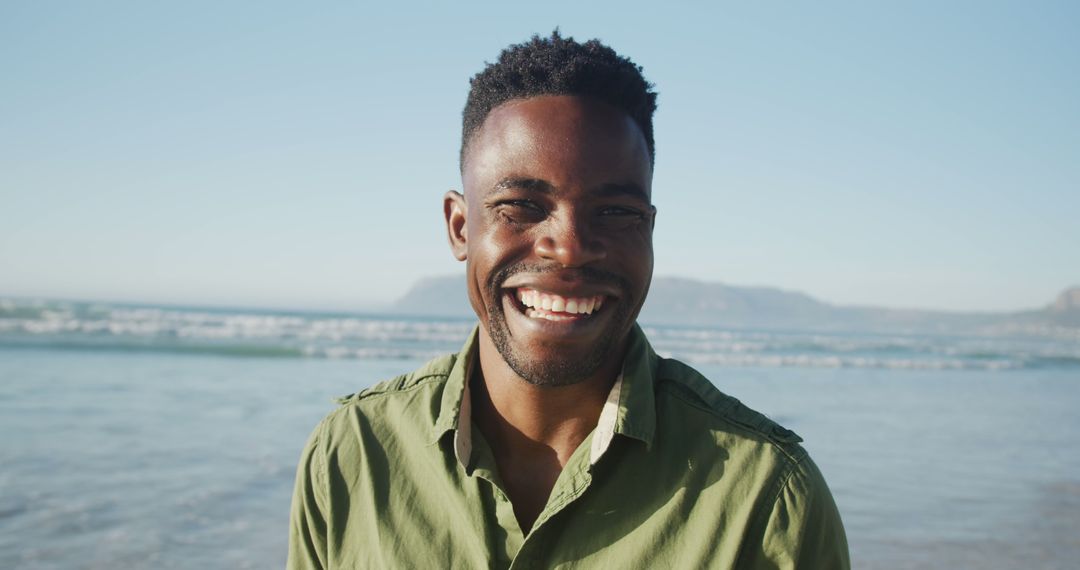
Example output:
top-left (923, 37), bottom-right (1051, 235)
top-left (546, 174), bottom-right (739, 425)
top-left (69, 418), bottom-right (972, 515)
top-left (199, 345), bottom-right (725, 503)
top-left (285, 424), bottom-right (327, 570)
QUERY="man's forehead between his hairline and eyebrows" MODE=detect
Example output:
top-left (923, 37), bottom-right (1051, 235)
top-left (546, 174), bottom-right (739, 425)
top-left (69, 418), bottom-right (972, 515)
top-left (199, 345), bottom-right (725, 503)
top-left (462, 95), bottom-right (652, 193)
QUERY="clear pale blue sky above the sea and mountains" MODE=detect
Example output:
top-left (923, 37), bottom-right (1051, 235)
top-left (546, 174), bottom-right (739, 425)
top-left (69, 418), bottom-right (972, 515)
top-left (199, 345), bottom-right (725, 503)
top-left (0, 1), bottom-right (1080, 310)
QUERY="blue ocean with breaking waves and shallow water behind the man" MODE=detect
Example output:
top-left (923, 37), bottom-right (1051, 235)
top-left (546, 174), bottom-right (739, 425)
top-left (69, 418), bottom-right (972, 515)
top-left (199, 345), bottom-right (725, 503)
top-left (0, 299), bottom-right (1080, 569)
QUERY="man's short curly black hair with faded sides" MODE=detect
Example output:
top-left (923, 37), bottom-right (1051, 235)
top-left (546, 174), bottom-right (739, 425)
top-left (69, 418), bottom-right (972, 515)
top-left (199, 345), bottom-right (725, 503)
top-left (459, 29), bottom-right (657, 169)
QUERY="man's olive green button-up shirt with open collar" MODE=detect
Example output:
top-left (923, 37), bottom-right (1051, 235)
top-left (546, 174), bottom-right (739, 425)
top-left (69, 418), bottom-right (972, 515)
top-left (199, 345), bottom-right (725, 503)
top-left (288, 327), bottom-right (849, 569)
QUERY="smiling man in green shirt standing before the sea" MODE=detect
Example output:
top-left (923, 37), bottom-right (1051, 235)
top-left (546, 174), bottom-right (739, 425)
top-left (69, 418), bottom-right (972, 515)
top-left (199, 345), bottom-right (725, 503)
top-left (288, 32), bottom-right (848, 569)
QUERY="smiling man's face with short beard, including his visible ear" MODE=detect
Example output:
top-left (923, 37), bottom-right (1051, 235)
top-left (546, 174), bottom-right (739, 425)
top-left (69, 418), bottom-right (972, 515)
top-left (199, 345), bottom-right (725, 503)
top-left (445, 96), bottom-right (656, 385)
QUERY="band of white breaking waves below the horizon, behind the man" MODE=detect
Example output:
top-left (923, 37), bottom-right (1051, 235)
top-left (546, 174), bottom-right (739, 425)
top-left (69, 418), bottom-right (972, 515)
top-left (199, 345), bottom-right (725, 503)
top-left (0, 300), bottom-right (1080, 370)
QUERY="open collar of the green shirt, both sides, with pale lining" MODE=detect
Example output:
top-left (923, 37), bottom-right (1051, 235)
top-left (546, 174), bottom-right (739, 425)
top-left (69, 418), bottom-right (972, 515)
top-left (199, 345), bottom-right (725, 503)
top-left (432, 324), bottom-right (658, 469)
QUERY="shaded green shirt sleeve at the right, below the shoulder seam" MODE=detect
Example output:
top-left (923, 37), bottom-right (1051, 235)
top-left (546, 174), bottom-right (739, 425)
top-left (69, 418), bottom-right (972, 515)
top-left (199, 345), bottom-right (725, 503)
top-left (740, 457), bottom-right (851, 570)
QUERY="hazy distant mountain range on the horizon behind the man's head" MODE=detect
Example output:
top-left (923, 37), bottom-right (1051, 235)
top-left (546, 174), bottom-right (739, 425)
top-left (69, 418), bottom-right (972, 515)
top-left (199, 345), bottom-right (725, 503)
top-left (392, 275), bottom-right (1080, 335)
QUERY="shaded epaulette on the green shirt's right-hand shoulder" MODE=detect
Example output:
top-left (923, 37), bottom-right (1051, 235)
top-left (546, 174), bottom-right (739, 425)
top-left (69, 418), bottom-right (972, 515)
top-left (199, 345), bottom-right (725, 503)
top-left (656, 358), bottom-right (807, 467)
